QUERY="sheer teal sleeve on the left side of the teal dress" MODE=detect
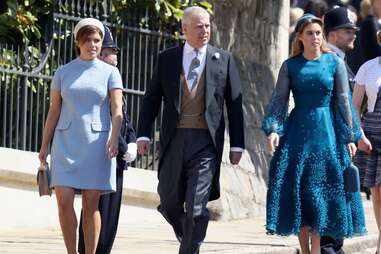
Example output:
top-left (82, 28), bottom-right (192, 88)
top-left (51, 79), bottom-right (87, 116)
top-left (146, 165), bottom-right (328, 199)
top-left (262, 61), bottom-right (290, 136)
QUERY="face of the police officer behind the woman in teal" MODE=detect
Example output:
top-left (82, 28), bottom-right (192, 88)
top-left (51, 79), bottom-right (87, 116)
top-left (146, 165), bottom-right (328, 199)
top-left (328, 28), bottom-right (356, 52)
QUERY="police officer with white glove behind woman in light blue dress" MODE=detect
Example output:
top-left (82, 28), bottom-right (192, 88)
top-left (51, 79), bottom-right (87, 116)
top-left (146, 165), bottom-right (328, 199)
top-left (78, 26), bottom-right (137, 254)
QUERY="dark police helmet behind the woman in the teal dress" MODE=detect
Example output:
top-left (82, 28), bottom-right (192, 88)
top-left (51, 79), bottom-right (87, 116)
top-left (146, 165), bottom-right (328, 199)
top-left (324, 7), bottom-right (358, 33)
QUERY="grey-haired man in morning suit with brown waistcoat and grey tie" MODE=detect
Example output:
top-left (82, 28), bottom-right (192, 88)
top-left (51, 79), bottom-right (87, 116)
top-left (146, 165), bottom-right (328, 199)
top-left (137, 6), bottom-right (244, 254)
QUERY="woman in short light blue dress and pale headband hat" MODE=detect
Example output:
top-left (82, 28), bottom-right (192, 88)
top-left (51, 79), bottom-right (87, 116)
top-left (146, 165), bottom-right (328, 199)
top-left (39, 18), bottom-right (123, 254)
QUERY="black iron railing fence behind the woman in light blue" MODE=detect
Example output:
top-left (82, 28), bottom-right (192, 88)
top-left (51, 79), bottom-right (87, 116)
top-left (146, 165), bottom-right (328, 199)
top-left (0, 0), bottom-right (183, 170)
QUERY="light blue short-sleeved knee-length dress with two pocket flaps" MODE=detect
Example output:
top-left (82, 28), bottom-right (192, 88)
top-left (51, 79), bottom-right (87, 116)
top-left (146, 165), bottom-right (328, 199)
top-left (51, 58), bottom-right (123, 194)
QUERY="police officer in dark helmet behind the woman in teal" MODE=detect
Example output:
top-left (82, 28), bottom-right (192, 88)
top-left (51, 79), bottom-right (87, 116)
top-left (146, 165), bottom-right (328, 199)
top-left (320, 7), bottom-right (358, 254)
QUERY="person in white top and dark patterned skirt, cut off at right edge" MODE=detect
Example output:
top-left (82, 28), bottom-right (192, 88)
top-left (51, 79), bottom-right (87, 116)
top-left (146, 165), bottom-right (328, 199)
top-left (353, 30), bottom-right (381, 253)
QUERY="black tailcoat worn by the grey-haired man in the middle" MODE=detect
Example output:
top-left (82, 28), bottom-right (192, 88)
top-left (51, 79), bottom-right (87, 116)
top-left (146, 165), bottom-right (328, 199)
top-left (138, 45), bottom-right (245, 200)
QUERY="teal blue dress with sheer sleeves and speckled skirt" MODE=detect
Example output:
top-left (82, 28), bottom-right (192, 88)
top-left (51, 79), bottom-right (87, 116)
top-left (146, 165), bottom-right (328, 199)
top-left (262, 53), bottom-right (366, 238)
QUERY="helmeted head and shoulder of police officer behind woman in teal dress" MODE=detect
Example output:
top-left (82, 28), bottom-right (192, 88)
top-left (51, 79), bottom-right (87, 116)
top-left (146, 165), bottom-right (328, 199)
top-left (324, 7), bottom-right (359, 89)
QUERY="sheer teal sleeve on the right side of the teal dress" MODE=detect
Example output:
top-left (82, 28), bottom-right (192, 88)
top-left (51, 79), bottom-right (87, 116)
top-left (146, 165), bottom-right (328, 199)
top-left (332, 59), bottom-right (361, 144)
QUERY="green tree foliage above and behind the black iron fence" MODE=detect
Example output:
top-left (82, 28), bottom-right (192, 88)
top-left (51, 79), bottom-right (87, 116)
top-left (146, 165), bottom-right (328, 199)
top-left (0, 0), bottom-right (212, 45)
